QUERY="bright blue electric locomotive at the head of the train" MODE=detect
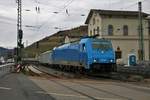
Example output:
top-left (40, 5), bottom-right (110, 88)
top-left (51, 38), bottom-right (116, 71)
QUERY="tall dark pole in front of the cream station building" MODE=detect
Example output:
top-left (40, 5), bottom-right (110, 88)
top-left (138, 2), bottom-right (145, 61)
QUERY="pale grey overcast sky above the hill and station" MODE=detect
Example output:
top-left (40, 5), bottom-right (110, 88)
top-left (0, 0), bottom-right (150, 48)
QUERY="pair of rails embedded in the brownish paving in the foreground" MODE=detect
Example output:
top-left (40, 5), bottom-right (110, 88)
top-left (32, 74), bottom-right (132, 100)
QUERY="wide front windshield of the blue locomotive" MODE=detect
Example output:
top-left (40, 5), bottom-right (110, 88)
top-left (92, 41), bottom-right (112, 50)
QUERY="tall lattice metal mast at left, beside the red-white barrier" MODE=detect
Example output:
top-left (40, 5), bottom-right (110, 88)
top-left (17, 0), bottom-right (23, 64)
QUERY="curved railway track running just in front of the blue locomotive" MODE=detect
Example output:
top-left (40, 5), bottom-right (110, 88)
top-left (24, 65), bottom-right (143, 82)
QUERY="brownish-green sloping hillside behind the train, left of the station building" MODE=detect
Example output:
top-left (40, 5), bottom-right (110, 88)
top-left (23, 26), bottom-right (88, 58)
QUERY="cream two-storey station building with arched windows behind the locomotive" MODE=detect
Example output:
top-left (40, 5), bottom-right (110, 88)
top-left (85, 9), bottom-right (150, 63)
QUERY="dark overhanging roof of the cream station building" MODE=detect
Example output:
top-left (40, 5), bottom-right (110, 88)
top-left (85, 9), bottom-right (149, 24)
